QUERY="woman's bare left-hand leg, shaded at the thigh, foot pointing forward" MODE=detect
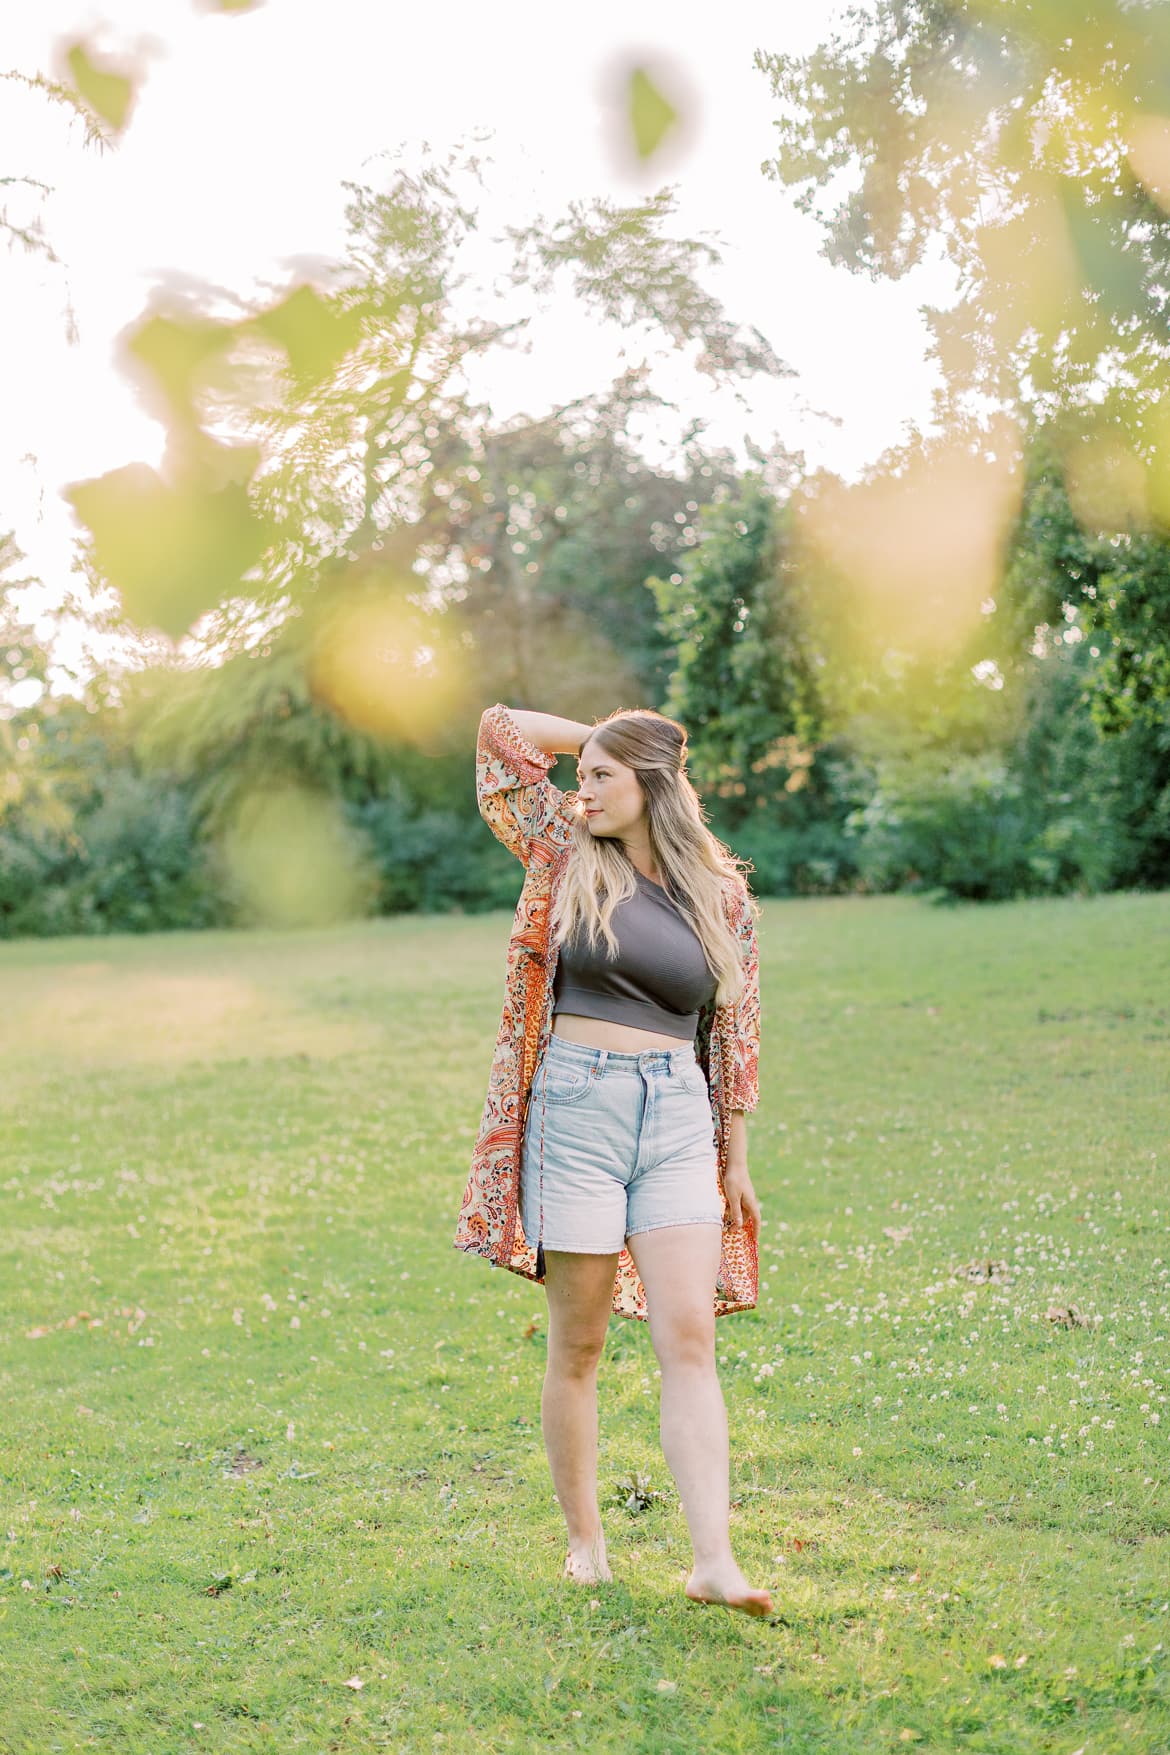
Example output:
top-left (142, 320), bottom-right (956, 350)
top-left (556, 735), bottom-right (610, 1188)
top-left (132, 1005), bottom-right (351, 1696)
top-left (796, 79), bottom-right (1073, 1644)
top-left (540, 1250), bottom-right (617, 1585)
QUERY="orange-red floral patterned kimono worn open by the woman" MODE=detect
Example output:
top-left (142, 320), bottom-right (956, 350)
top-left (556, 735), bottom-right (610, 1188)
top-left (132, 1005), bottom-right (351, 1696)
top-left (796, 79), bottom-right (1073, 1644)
top-left (454, 704), bottom-right (760, 1318)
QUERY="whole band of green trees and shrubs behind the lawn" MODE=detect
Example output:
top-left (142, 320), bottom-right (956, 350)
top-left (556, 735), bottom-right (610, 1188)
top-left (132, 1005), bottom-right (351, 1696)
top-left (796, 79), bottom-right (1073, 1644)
top-left (9, 51), bottom-right (1170, 932)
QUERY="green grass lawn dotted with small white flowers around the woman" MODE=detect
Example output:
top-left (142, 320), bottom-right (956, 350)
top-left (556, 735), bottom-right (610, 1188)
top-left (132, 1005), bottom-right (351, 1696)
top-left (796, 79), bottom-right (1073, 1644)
top-left (0, 895), bottom-right (1170, 1755)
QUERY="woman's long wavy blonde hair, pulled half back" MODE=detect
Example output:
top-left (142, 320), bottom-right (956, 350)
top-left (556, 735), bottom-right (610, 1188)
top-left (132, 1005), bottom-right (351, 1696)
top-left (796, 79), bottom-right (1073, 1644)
top-left (551, 707), bottom-right (760, 1006)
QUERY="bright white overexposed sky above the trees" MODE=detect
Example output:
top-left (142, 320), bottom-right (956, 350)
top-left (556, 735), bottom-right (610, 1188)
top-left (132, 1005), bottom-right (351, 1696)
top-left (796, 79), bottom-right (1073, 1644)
top-left (0, 0), bottom-right (951, 691)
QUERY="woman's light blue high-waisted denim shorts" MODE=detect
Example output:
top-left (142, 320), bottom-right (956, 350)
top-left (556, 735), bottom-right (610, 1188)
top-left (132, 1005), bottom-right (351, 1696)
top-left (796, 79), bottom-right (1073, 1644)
top-left (521, 1035), bottom-right (723, 1255)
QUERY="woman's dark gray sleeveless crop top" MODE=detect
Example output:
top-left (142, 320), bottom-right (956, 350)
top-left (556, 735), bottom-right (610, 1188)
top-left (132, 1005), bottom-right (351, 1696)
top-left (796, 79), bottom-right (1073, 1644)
top-left (553, 870), bottom-right (716, 1041)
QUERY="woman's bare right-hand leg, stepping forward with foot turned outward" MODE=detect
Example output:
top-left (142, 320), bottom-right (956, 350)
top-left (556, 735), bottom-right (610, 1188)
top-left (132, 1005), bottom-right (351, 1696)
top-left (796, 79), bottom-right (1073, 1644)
top-left (628, 1225), bottom-right (772, 1615)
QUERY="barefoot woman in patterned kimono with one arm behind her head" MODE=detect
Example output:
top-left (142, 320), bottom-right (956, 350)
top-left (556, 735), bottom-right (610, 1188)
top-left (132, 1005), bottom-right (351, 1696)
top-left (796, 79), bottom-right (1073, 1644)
top-left (454, 704), bottom-right (772, 1615)
